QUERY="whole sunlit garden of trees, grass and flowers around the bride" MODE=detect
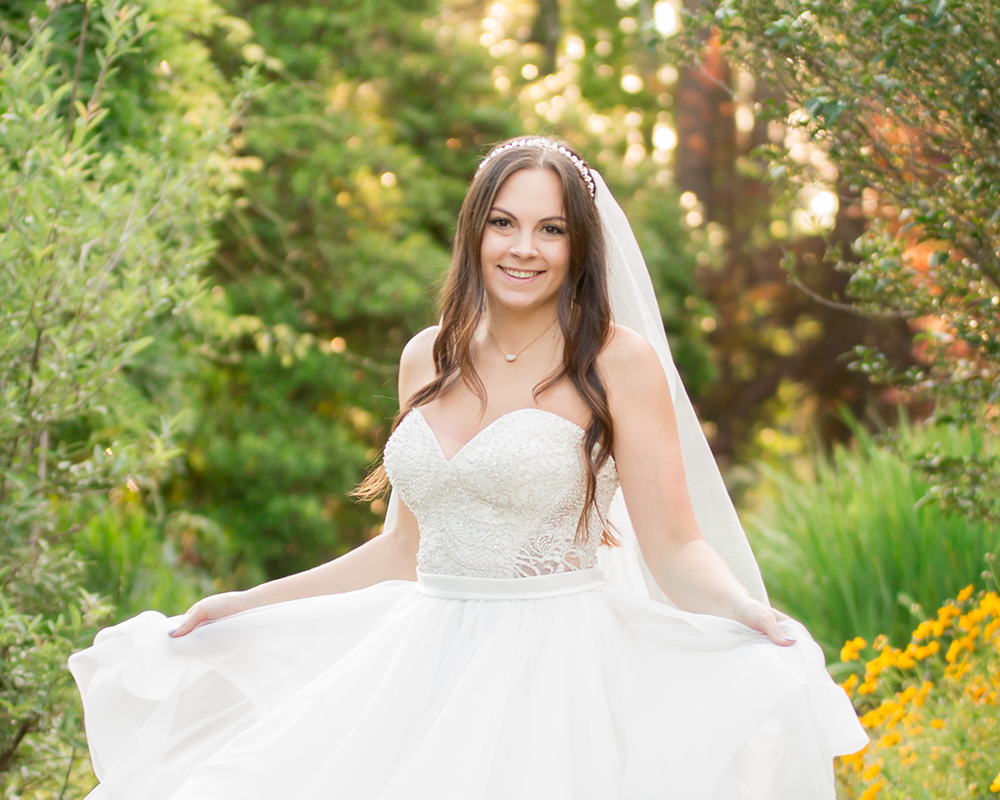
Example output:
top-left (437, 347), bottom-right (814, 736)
top-left (0, 0), bottom-right (1000, 800)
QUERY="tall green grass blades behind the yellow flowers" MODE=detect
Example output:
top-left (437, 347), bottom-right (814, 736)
top-left (746, 421), bottom-right (1000, 662)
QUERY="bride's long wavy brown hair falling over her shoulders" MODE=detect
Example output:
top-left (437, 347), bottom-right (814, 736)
top-left (352, 139), bottom-right (617, 544)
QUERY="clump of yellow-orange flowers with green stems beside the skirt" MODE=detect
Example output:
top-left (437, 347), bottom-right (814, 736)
top-left (838, 586), bottom-right (1000, 800)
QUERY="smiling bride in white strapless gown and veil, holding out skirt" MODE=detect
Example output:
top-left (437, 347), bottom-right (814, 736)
top-left (70, 138), bottom-right (867, 800)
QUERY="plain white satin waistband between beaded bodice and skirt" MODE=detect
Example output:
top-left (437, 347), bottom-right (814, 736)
top-left (417, 567), bottom-right (605, 600)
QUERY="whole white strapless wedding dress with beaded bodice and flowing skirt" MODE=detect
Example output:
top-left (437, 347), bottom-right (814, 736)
top-left (70, 409), bottom-right (867, 800)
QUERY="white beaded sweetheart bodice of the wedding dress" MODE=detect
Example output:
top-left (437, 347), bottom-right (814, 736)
top-left (384, 408), bottom-right (618, 578)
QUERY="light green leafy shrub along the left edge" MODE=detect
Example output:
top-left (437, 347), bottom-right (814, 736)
top-left (0, 0), bottom-right (242, 797)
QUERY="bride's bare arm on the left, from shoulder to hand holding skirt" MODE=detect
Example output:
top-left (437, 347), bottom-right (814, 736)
top-left (170, 328), bottom-right (437, 638)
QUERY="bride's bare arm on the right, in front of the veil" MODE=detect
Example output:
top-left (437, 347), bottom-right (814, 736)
top-left (601, 326), bottom-right (791, 644)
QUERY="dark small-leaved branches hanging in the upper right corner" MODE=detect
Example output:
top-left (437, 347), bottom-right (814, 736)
top-left (696, 0), bottom-right (1000, 522)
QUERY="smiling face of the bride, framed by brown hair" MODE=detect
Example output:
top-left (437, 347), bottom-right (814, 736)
top-left (480, 169), bottom-right (569, 311)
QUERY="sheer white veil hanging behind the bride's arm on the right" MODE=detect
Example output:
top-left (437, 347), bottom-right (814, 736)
top-left (590, 169), bottom-right (767, 603)
